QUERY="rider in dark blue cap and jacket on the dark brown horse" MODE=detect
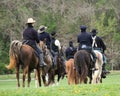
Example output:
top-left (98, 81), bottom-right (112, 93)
top-left (77, 25), bottom-right (97, 70)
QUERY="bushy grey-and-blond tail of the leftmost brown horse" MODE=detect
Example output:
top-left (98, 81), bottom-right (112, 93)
top-left (6, 40), bottom-right (22, 69)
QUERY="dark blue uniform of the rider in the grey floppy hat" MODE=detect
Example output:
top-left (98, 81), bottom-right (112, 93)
top-left (39, 32), bottom-right (51, 49)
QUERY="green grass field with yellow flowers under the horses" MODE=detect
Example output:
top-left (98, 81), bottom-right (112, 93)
top-left (0, 71), bottom-right (120, 96)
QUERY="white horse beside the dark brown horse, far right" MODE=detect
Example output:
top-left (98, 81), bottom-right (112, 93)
top-left (92, 50), bottom-right (103, 84)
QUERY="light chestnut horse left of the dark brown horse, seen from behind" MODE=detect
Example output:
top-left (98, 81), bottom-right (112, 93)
top-left (65, 59), bottom-right (77, 85)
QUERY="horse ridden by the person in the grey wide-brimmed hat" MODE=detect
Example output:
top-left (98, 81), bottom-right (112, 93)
top-left (35, 40), bottom-right (54, 87)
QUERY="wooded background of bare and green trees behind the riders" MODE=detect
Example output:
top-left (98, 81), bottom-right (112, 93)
top-left (0, 0), bottom-right (120, 74)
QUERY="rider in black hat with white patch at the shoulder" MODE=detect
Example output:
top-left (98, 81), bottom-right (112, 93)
top-left (51, 32), bottom-right (61, 66)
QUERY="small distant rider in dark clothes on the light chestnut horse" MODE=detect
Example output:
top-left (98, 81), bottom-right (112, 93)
top-left (65, 41), bottom-right (77, 60)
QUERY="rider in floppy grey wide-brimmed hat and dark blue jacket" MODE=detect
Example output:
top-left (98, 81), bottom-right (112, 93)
top-left (38, 25), bottom-right (51, 50)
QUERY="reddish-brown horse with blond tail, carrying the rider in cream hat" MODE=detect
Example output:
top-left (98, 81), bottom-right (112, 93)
top-left (6, 40), bottom-right (41, 87)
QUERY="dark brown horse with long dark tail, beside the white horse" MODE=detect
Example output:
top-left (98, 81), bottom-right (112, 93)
top-left (74, 50), bottom-right (92, 83)
